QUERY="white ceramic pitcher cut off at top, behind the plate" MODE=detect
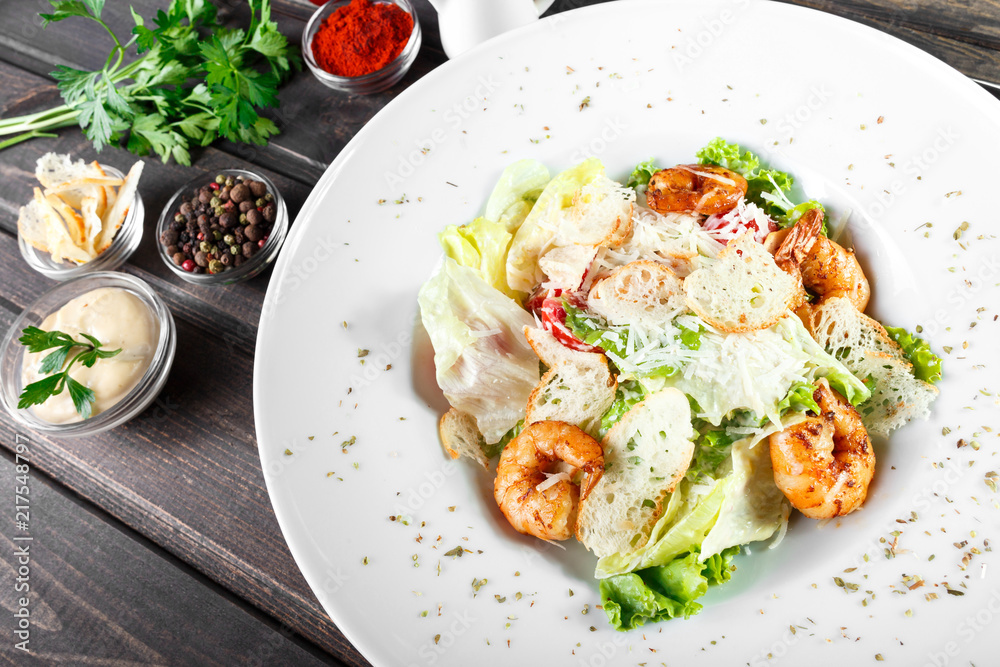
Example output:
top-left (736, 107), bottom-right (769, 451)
top-left (430, 0), bottom-right (555, 58)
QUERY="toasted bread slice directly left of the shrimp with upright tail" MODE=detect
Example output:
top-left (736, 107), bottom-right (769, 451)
top-left (684, 231), bottom-right (805, 333)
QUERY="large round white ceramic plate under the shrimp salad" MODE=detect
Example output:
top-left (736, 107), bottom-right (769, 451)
top-left (254, 0), bottom-right (1000, 666)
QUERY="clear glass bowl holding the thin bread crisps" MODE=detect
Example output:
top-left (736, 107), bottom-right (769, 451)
top-left (17, 164), bottom-right (146, 280)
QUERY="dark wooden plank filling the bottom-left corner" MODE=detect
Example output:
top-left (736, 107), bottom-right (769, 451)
top-left (0, 448), bottom-right (341, 666)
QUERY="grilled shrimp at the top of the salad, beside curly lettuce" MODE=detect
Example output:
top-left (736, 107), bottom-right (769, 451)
top-left (646, 164), bottom-right (747, 215)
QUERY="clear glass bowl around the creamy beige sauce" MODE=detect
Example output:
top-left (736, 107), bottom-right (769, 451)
top-left (0, 272), bottom-right (177, 437)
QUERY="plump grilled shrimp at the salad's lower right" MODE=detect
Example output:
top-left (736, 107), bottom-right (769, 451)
top-left (769, 379), bottom-right (875, 519)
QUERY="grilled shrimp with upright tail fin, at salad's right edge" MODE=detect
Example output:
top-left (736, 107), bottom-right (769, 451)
top-left (774, 208), bottom-right (871, 313)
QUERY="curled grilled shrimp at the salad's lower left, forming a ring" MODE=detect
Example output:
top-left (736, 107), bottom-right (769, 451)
top-left (494, 421), bottom-right (604, 540)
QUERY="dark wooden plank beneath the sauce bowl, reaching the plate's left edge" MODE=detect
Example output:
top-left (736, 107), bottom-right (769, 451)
top-left (0, 234), bottom-right (365, 665)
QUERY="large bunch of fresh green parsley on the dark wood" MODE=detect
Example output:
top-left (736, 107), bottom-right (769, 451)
top-left (0, 0), bottom-right (301, 164)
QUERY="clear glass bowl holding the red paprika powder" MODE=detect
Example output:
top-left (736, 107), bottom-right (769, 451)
top-left (302, 0), bottom-right (422, 95)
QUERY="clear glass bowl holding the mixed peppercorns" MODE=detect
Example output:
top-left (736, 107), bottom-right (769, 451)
top-left (156, 169), bottom-right (288, 285)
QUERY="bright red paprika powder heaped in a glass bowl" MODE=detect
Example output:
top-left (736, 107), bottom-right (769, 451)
top-left (312, 0), bottom-right (413, 77)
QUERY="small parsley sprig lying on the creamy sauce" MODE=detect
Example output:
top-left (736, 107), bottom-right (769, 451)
top-left (17, 326), bottom-right (122, 419)
